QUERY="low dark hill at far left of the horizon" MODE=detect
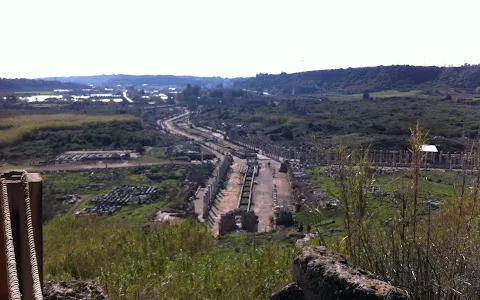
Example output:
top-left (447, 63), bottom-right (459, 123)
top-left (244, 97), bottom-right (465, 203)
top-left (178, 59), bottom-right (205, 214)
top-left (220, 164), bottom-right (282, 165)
top-left (0, 78), bottom-right (86, 92)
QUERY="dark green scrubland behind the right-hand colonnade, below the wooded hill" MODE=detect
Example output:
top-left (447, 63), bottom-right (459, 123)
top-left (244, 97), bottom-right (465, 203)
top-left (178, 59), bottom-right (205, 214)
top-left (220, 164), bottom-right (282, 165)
top-left (198, 96), bottom-right (480, 152)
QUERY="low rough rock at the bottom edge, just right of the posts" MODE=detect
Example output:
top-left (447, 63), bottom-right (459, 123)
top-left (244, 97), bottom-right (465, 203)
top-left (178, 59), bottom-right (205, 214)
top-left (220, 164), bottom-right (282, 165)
top-left (43, 280), bottom-right (108, 300)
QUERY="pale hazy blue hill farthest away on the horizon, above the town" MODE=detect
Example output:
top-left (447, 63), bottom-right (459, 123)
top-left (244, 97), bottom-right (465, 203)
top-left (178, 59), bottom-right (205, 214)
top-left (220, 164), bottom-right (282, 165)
top-left (42, 74), bottom-right (240, 88)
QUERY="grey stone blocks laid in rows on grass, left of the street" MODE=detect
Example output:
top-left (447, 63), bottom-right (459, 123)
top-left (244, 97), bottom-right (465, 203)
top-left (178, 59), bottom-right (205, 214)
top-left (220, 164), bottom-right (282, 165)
top-left (75, 185), bottom-right (158, 215)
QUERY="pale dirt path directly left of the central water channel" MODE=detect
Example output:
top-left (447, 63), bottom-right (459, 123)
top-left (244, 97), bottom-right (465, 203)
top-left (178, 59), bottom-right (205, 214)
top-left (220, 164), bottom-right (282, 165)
top-left (208, 161), bottom-right (243, 236)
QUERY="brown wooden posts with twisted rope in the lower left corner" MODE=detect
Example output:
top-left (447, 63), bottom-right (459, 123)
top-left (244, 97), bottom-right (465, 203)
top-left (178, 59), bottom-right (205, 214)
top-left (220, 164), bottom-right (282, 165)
top-left (0, 171), bottom-right (43, 300)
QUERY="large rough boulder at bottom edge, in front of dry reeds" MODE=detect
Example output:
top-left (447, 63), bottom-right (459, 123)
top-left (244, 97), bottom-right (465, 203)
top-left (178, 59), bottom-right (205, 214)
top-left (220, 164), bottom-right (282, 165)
top-left (268, 247), bottom-right (410, 300)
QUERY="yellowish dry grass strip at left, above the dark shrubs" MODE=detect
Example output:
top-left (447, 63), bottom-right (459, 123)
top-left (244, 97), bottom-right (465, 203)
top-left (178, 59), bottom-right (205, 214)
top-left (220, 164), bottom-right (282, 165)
top-left (0, 114), bottom-right (139, 145)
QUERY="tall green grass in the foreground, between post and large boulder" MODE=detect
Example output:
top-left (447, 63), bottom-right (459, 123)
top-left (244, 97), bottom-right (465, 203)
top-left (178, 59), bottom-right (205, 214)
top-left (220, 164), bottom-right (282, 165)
top-left (44, 216), bottom-right (295, 300)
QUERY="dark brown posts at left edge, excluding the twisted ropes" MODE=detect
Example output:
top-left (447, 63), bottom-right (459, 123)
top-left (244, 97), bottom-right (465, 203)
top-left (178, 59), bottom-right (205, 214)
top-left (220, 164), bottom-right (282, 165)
top-left (0, 172), bottom-right (43, 300)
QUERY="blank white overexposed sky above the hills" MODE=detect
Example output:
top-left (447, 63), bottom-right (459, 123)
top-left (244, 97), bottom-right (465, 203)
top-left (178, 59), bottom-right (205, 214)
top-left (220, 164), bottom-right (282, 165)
top-left (0, 0), bottom-right (480, 78)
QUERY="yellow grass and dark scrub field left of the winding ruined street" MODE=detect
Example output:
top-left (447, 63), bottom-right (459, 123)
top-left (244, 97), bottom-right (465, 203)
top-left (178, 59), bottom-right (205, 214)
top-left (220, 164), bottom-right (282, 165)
top-left (0, 114), bottom-right (156, 164)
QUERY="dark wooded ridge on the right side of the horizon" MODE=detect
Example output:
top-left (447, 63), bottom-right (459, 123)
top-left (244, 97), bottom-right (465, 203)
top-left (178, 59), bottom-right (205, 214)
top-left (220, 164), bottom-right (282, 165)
top-left (234, 65), bottom-right (480, 94)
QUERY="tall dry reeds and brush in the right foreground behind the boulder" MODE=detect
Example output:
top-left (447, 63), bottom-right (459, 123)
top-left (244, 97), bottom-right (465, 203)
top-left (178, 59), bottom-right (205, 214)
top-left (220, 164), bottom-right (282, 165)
top-left (322, 123), bottom-right (480, 300)
